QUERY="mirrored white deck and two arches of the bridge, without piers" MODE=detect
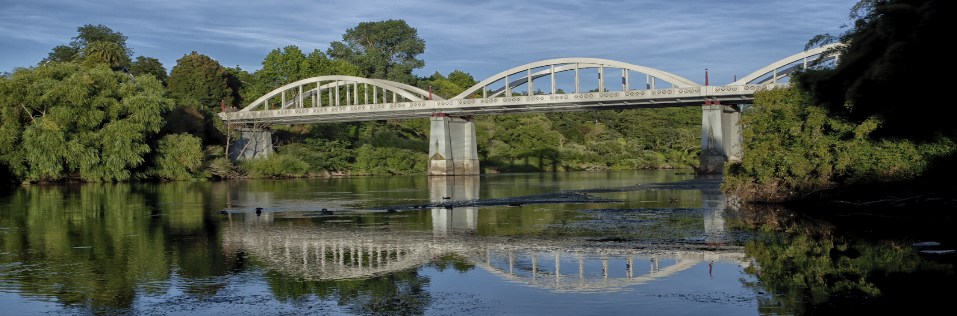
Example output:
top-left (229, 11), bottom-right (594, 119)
top-left (223, 221), bottom-right (748, 292)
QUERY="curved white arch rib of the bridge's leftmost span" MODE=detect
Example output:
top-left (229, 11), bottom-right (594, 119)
top-left (240, 75), bottom-right (442, 111)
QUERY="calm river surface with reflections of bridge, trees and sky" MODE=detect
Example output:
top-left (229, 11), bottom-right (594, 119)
top-left (0, 171), bottom-right (955, 315)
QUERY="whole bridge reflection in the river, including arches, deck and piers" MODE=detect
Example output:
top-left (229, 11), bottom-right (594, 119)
top-left (223, 177), bottom-right (749, 292)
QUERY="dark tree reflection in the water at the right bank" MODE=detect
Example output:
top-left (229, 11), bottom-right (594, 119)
top-left (734, 205), bottom-right (957, 315)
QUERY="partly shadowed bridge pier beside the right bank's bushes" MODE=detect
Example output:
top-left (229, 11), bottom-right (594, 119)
top-left (698, 101), bottom-right (744, 174)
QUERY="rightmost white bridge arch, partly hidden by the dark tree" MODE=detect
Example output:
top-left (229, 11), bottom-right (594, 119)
top-left (730, 43), bottom-right (843, 86)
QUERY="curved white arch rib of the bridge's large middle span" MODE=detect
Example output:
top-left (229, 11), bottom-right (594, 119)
top-left (452, 58), bottom-right (698, 100)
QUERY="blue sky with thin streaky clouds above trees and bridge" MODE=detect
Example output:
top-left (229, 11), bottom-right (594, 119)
top-left (0, 0), bottom-right (857, 84)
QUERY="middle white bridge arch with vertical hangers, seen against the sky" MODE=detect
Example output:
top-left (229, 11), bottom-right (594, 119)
top-left (451, 58), bottom-right (698, 100)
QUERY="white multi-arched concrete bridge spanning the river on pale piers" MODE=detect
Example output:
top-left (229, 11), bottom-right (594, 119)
top-left (219, 44), bottom-right (840, 175)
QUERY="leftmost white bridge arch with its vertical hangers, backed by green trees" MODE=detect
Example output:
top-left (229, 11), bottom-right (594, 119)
top-left (240, 75), bottom-right (443, 111)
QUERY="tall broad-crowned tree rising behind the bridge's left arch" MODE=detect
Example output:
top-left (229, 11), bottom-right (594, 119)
top-left (327, 20), bottom-right (425, 84)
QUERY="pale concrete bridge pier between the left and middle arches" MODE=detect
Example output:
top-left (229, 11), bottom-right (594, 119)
top-left (429, 113), bottom-right (479, 176)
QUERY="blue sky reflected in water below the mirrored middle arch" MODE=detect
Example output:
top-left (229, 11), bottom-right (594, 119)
top-left (422, 262), bottom-right (757, 315)
